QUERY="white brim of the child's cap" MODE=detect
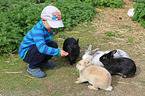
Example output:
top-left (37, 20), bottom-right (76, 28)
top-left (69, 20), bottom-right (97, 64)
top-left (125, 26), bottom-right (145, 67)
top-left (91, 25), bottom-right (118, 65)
top-left (47, 20), bottom-right (64, 28)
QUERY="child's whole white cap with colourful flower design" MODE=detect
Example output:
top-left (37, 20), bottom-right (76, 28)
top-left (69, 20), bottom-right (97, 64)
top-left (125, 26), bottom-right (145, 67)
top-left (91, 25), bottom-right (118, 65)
top-left (41, 6), bottom-right (64, 28)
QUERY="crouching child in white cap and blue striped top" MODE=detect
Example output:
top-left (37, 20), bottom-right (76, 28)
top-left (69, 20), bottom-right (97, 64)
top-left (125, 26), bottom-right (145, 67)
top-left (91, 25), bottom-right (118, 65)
top-left (19, 6), bottom-right (68, 78)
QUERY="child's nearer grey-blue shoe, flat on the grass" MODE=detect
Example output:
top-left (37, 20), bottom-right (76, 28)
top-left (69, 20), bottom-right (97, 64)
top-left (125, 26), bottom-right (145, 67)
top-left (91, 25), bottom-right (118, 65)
top-left (27, 66), bottom-right (46, 78)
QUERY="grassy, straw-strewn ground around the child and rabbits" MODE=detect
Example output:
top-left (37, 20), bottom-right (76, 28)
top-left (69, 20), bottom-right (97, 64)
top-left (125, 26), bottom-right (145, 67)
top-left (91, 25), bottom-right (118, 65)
top-left (0, 0), bottom-right (145, 96)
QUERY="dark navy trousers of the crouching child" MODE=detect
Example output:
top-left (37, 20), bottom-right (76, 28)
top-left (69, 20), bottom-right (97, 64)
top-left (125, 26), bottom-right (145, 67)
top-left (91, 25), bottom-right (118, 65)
top-left (24, 41), bottom-right (58, 69)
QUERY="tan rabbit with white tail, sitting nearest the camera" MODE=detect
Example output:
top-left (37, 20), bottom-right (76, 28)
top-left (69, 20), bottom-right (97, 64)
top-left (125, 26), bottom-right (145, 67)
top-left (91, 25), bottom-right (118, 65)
top-left (75, 56), bottom-right (113, 91)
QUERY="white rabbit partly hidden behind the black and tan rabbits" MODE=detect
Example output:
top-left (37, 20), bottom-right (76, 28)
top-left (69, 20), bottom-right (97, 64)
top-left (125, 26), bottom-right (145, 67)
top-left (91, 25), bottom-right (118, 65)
top-left (82, 45), bottom-right (130, 67)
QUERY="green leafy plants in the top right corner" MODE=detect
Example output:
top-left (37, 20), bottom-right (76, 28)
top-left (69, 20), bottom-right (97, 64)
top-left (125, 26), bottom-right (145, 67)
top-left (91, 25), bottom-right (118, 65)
top-left (132, 0), bottom-right (145, 28)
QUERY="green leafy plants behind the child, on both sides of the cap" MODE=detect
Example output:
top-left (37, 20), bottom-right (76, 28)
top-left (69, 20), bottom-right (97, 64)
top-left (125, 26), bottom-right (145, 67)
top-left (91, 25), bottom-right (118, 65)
top-left (0, 0), bottom-right (95, 52)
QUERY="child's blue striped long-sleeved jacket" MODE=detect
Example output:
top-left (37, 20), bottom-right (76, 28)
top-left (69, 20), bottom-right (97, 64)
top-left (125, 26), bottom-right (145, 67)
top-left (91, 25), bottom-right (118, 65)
top-left (19, 19), bottom-right (60, 60)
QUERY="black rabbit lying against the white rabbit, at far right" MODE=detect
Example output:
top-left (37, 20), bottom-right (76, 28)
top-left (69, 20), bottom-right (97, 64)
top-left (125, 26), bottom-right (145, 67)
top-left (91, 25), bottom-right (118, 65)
top-left (100, 50), bottom-right (136, 78)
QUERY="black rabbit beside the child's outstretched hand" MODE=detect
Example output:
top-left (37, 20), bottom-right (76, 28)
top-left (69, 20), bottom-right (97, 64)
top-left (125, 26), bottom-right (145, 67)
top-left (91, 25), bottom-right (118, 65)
top-left (63, 38), bottom-right (80, 65)
